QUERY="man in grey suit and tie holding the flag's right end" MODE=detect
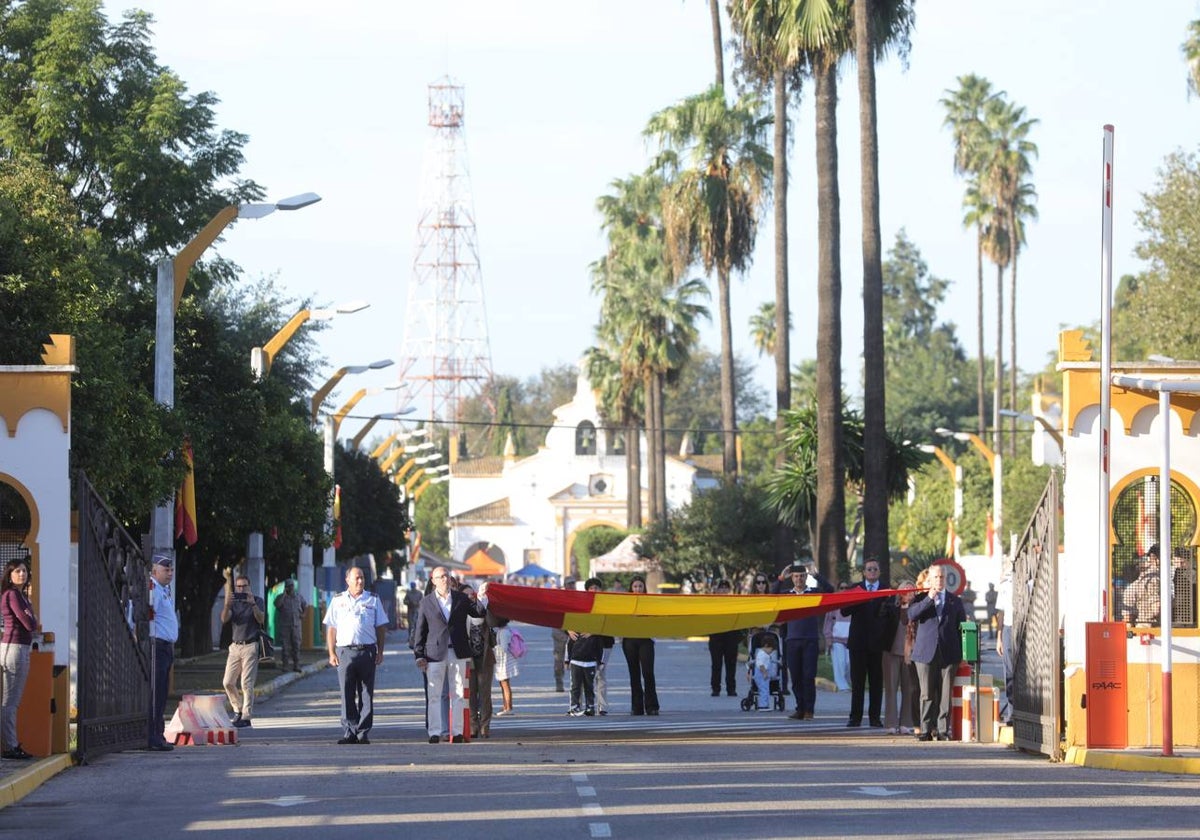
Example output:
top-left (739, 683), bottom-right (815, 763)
top-left (908, 565), bottom-right (967, 740)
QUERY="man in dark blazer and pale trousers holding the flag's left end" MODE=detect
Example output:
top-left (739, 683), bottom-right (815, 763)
top-left (413, 566), bottom-right (487, 744)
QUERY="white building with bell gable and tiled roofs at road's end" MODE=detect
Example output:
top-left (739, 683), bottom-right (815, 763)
top-left (449, 365), bottom-right (720, 575)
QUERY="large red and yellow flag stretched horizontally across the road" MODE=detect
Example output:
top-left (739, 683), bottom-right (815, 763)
top-left (487, 583), bottom-right (898, 638)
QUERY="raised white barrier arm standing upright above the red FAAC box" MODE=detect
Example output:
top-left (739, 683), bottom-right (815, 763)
top-left (1099, 125), bottom-right (1114, 622)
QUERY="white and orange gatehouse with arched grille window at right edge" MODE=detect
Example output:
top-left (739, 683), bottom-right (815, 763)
top-left (1058, 330), bottom-right (1200, 749)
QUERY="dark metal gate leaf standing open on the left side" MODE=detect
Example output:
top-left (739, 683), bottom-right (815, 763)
top-left (76, 472), bottom-right (150, 763)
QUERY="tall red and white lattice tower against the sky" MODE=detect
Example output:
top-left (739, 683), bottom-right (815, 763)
top-left (400, 77), bottom-right (492, 425)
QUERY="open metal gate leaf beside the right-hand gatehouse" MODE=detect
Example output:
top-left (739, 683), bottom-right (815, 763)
top-left (1012, 473), bottom-right (1062, 761)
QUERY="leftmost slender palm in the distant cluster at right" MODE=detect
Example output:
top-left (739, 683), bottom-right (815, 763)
top-left (942, 73), bottom-right (992, 434)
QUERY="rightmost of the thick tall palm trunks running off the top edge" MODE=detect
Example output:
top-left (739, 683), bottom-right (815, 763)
top-left (854, 0), bottom-right (912, 583)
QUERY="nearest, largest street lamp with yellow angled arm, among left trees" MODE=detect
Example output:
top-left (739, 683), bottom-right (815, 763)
top-left (150, 192), bottom-right (320, 557)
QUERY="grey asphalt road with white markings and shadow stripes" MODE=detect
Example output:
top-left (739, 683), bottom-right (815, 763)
top-left (0, 628), bottom-right (1200, 840)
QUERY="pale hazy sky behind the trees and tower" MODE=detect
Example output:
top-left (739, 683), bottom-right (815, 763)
top-left (106, 0), bottom-right (1200, 434)
